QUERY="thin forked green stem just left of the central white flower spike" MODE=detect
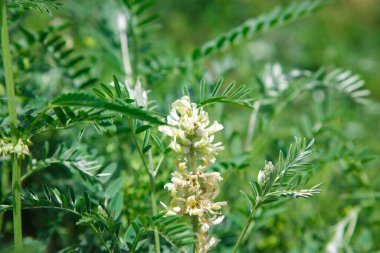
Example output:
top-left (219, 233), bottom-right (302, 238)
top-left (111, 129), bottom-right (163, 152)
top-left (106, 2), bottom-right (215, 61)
top-left (128, 117), bottom-right (161, 253)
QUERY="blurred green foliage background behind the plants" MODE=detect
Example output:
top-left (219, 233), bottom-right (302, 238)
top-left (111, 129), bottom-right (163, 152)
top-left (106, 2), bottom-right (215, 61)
top-left (0, 0), bottom-right (380, 253)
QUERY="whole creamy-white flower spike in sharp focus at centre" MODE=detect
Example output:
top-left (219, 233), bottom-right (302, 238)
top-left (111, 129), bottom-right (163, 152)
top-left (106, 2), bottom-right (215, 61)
top-left (159, 96), bottom-right (227, 252)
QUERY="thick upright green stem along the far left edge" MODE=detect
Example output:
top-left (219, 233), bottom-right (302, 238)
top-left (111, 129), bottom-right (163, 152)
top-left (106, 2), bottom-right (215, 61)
top-left (0, 0), bottom-right (22, 249)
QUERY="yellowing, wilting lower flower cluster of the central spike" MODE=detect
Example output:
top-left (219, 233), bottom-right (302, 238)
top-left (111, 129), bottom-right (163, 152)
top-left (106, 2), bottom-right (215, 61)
top-left (162, 160), bottom-right (227, 252)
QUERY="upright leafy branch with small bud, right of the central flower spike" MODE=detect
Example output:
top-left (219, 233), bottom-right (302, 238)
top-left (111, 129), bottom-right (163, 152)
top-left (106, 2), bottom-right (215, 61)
top-left (233, 138), bottom-right (320, 252)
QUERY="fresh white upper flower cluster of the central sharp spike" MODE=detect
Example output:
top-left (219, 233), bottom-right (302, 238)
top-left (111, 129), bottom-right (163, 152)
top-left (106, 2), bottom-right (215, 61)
top-left (158, 96), bottom-right (223, 162)
